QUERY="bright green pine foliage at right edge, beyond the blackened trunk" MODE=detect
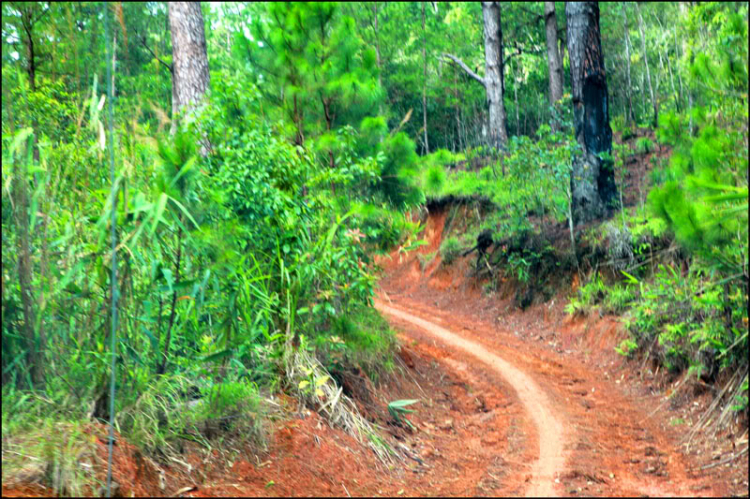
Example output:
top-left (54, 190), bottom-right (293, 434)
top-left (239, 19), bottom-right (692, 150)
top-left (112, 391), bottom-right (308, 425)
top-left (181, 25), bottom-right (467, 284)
top-left (649, 5), bottom-right (748, 278)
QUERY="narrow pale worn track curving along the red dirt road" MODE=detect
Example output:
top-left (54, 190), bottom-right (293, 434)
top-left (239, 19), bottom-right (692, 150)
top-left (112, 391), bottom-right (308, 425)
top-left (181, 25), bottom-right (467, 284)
top-left (375, 301), bottom-right (565, 497)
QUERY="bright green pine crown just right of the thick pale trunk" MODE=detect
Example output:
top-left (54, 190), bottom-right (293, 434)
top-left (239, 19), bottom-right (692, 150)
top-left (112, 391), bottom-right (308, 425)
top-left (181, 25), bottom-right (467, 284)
top-left (238, 2), bottom-right (381, 167)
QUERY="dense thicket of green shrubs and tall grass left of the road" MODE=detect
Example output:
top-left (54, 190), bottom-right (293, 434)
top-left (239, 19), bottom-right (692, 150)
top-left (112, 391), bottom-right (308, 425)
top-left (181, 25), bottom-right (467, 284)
top-left (3, 63), bottom-right (400, 468)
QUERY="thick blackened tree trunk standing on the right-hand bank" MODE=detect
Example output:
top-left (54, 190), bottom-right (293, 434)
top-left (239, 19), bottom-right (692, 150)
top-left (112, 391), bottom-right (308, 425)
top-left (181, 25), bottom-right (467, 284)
top-left (565, 2), bottom-right (616, 224)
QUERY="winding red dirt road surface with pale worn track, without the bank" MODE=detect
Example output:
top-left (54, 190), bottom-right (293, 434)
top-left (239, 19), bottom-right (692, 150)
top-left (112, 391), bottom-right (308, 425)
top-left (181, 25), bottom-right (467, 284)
top-left (376, 295), bottom-right (727, 496)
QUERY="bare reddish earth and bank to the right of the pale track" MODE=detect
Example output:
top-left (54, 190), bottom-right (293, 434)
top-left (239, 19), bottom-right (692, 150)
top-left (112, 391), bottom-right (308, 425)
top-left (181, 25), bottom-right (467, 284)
top-left (381, 206), bottom-right (748, 496)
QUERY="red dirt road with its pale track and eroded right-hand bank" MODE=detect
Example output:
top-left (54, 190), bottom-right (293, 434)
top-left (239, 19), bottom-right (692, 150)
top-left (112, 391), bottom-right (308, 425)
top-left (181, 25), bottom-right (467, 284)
top-left (376, 208), bottom-right (747, 497)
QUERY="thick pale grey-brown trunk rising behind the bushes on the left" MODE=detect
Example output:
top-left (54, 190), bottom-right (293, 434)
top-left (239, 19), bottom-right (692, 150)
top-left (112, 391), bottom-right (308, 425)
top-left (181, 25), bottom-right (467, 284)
top-left (167, 2), bottom-right (210, 130)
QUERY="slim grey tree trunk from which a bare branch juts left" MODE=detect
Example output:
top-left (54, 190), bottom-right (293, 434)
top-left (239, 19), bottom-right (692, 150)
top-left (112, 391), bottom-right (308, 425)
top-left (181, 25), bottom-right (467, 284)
top-left (482, 2), bottom-right (508, 149)
